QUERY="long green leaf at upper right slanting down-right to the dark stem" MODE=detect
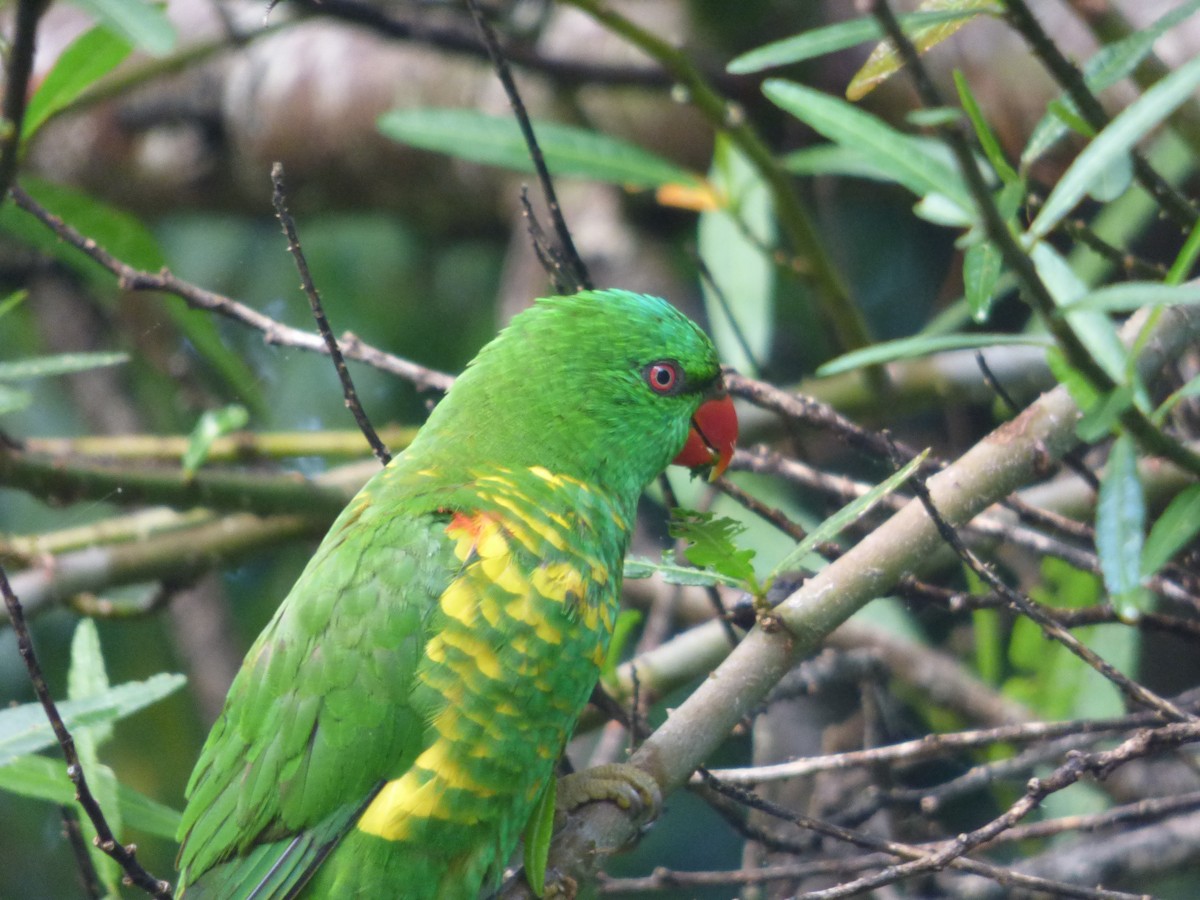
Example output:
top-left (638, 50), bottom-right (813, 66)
top-left (762, 78), bottom-right (974, 214)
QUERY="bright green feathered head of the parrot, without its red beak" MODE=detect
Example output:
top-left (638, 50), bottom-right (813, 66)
top-left (406, 290), bottom-right (720, 499)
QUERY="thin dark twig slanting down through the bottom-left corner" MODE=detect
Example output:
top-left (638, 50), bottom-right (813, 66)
top-left (0, 565), bottom-right (173, 900)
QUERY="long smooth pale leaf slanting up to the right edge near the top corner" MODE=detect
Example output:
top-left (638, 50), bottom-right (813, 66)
top-left (1025, 56), bottom-right (1200, 242)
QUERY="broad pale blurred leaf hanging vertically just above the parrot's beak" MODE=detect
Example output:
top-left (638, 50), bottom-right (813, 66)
top-left (697, 134), bottom-right (775, 374)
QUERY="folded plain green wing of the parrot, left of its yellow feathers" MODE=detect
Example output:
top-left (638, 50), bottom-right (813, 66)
top-left (179, 466), bottom-right (460, 900)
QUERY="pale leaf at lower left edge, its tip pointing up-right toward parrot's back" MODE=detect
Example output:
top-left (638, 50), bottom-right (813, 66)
top-left (0, 672), bottom-right (187, 766)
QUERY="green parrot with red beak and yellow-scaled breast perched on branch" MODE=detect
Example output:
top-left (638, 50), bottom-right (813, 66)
top-left (179, 290), bottom-right (737, 900)
